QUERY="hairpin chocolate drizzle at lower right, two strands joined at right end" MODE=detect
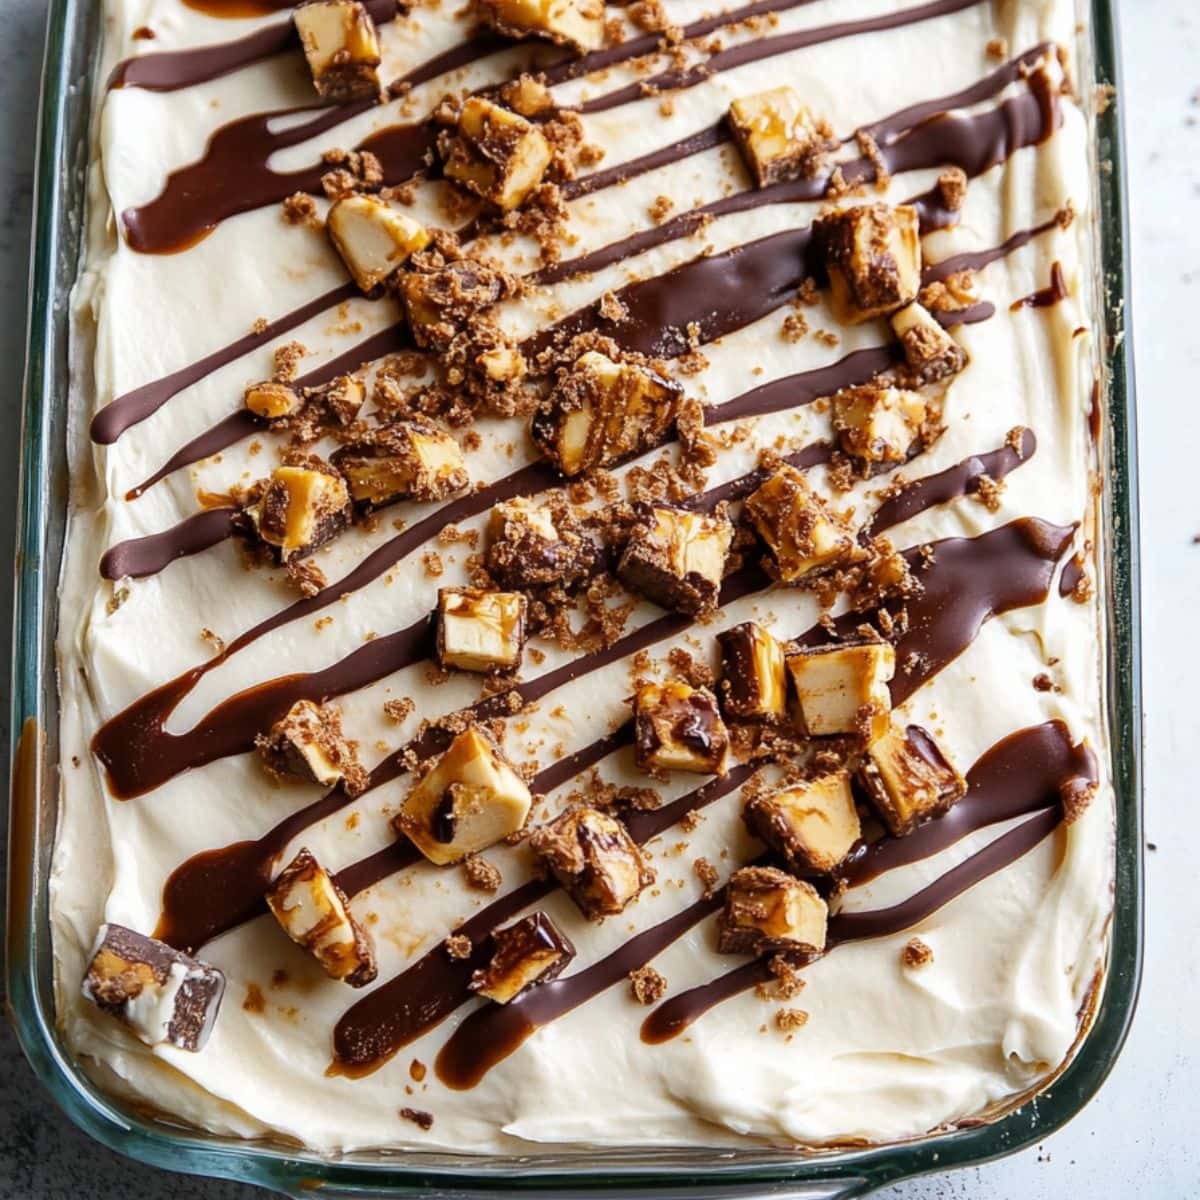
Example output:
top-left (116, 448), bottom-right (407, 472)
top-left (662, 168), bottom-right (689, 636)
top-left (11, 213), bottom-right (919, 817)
top-left (642, 721), bottom-right (1099, 1044)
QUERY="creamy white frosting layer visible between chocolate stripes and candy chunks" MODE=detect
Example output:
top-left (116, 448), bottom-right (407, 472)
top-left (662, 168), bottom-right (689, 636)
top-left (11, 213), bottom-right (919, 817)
top-left (52, 0), bottom-right (1112, 1153)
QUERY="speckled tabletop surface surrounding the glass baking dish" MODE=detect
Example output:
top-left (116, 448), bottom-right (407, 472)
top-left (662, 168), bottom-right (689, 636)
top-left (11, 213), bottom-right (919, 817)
top-left (0, 0), bottom-right (1200, 1200)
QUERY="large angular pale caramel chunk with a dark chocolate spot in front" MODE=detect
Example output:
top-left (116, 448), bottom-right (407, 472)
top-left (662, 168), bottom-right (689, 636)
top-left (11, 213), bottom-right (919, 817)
top-left (397, 725), bottom-right (533, 866)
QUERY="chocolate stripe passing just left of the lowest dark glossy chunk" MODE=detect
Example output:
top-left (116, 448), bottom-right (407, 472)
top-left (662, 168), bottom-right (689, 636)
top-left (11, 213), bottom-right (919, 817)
top-left (329, 766), bottom-right (755, 1079)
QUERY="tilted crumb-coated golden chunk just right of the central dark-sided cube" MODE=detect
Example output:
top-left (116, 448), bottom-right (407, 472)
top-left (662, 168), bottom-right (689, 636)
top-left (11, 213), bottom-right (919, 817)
top-left (744, 466), bottom-right (858, 583)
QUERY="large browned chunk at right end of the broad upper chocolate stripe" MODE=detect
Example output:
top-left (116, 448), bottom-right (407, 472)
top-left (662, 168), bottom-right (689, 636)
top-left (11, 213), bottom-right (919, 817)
top-left (812, 203), bottom-right (920, 325)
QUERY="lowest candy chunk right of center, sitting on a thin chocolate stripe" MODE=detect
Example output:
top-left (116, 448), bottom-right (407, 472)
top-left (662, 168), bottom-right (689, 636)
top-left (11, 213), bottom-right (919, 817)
top-left (718, 866), bottom-right (829, 954)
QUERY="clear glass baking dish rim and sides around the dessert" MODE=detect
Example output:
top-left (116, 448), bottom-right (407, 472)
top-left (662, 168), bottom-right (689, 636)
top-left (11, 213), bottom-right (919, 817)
top-left (6, 0), bottom-right (1142, 1200)
